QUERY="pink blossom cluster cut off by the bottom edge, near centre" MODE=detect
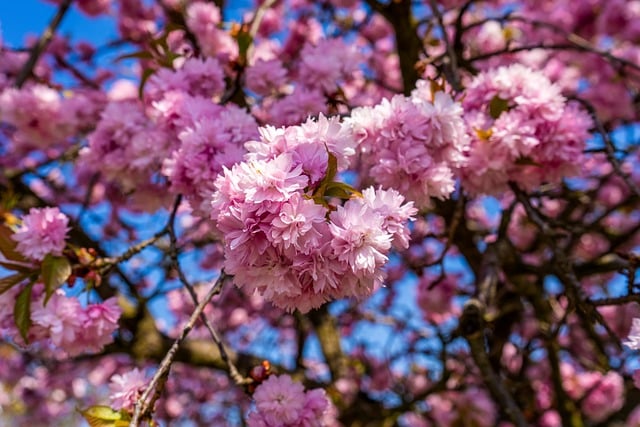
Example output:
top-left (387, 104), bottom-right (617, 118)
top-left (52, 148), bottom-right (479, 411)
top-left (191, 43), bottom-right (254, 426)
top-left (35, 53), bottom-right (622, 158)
top-left (247, 375), bottom-right (331, 427)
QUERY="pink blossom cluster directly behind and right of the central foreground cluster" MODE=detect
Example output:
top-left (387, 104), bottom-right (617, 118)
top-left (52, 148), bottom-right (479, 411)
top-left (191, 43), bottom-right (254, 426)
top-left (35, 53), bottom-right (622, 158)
top-left (348, 81), bottom-right (469, 207)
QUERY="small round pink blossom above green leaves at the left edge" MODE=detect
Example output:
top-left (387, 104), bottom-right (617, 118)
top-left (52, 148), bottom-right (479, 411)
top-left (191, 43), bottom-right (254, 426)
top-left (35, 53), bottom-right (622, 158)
top-left (11, 207), bottom-right (69, 261)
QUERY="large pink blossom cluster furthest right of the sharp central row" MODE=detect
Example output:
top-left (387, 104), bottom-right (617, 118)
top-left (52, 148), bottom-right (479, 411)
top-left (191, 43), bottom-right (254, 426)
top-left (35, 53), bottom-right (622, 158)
top-left (462, 64), bottom-right (591, 194)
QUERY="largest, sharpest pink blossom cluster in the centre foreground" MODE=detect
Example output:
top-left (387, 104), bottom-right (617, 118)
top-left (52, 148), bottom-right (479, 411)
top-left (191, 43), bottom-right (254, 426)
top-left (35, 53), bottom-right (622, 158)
top-left (211, 116), bottom-right (415, 312)
